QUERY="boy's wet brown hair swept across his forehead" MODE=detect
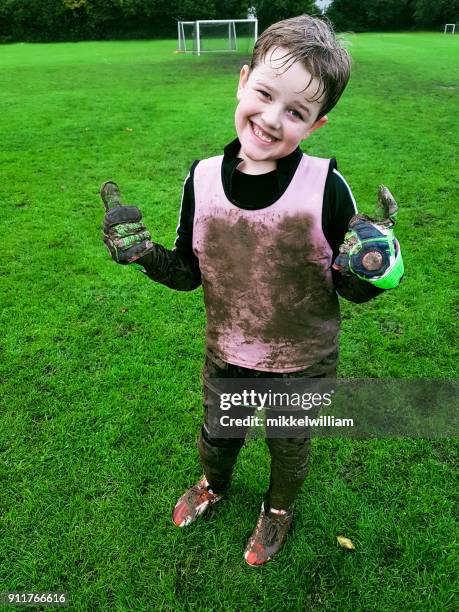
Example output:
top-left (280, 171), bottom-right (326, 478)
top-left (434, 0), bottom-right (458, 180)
top-left (250, 15), bottom-right (351, 119)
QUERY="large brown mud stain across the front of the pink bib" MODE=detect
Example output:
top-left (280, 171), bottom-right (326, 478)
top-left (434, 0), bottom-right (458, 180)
top-left (200, 216), bottom-right (338, 363)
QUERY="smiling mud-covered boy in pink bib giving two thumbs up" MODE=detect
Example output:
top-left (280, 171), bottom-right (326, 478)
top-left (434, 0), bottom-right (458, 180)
top-left (101, 15), bottom-right (403, 566)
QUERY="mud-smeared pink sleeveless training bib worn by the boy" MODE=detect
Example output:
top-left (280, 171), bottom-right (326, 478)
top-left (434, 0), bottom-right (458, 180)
top-left (193, 155), bottom-right (339, 372)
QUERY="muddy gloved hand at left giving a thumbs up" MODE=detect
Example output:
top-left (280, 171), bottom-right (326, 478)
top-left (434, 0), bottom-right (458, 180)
top-left (100, 181), bottom-right (153, 264)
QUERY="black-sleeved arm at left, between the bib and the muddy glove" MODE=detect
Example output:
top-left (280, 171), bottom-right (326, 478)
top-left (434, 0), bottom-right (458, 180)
top-left (137, 161), bottom-right (201, 291)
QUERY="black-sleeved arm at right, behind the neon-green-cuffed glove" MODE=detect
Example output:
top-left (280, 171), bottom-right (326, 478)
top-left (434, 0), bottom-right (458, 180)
top-left (322, 159), bottom-right (384, 304)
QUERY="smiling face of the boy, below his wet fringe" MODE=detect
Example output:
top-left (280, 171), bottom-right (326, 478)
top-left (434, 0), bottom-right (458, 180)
top-left (235, 48), bottom-right (327, 174)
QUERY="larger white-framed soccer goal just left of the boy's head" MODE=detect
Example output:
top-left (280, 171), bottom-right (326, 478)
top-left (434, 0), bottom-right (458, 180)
top-left (177, 19), bottom-right (258, 55)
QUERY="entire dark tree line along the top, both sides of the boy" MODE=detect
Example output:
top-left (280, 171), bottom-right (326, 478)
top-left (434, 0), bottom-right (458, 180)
top-left (0, 0), bottom-right (459, 42)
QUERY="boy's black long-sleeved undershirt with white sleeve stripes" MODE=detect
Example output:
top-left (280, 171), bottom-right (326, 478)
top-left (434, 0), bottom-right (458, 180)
top-left (138, 138), bottom-right (382, 302)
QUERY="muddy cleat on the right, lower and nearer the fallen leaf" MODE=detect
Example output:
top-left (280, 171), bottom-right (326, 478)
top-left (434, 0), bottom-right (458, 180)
top-left (244, 503), bottom-right (293, 566)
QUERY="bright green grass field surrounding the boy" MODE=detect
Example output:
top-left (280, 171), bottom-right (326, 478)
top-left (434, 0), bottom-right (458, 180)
top-left (0, 34), bottom-right (459, 612)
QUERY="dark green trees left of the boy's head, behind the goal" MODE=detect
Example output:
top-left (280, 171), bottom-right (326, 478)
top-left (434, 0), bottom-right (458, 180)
top-left (0, 0), bottom-right (318, 42)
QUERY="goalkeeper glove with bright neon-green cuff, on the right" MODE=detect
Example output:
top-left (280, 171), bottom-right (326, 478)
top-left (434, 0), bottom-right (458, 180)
top-left (333, 185), bottom-right (404, 289)
